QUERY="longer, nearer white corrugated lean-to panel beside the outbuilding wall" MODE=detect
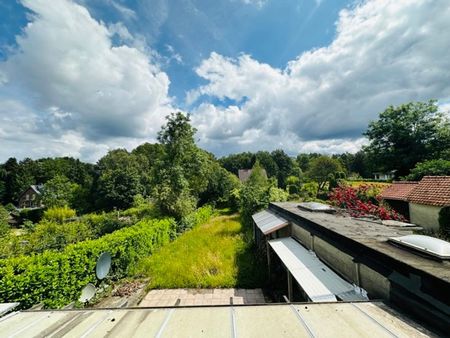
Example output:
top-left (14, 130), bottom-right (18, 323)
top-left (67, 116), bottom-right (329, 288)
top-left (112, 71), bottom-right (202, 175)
top-left (269, 237), bottom-right (367, 302)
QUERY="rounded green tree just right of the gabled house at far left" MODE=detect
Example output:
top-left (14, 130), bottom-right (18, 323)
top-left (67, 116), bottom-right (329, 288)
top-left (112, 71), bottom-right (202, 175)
top-left (42, 175), bottom-right (80, 208)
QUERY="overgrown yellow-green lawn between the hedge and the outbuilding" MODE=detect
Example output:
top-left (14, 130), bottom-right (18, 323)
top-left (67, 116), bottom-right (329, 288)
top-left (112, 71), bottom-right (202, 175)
top-left (137, 215), bottom-right (266, 288)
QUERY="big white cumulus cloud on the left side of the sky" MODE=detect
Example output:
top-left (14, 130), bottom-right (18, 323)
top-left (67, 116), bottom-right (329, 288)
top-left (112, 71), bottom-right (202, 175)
top-left (0, 0), bottom-right (172, 160)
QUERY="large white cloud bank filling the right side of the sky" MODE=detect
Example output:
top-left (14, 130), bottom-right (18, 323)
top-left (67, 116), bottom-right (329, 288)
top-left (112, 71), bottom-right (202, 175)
top-left (192, 0), bottom-right (450, 152)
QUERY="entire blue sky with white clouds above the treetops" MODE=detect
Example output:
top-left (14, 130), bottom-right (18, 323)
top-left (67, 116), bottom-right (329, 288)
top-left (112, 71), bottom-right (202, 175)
top-left (0, 0), bottom-right (450, 161)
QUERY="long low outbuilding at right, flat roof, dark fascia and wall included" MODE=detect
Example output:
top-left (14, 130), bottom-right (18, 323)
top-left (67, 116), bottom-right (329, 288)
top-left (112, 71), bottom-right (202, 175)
top-left (269, 202), bottom-right (450, 329)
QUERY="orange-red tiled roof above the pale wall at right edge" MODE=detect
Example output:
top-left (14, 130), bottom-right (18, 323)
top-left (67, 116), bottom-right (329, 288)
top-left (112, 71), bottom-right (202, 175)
top-left (408, 176), bottom-right (450, 207)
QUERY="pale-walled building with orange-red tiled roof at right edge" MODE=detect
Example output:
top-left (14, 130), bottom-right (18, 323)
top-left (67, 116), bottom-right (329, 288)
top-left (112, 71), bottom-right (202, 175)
top-left (408, 176), bottom-right (450, 230)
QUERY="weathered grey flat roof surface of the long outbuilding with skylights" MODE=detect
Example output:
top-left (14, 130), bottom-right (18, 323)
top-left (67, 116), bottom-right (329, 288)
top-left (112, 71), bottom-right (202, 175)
top-left (269, 202), bottom-right (450, 283)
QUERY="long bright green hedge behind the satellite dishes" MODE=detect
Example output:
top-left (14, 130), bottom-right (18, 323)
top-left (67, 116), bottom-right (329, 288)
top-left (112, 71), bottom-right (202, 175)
top-left (0, 219), bottom-right (176, 308)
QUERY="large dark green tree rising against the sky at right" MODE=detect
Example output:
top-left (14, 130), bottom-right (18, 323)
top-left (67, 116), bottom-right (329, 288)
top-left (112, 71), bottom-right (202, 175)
top-left (365, 100), bottom-right (450, 176)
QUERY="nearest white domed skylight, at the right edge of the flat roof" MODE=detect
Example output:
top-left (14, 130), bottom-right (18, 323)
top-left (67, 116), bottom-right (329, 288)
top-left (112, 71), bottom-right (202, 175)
top-left (389, 235), bottom-right (450, 259)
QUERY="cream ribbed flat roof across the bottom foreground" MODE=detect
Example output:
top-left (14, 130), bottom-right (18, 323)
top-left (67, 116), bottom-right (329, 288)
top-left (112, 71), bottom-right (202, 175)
top-left (0, 302), bottom-right (433, 338)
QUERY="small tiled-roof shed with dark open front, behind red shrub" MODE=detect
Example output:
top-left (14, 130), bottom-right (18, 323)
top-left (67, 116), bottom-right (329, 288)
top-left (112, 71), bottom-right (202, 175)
top-left (380, 181), bottom-right (419, 219)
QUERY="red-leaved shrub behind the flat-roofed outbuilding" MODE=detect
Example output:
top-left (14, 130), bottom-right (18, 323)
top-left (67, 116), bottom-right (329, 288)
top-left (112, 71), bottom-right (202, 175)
top-left (328, 185), bottom-right (405, 221)
